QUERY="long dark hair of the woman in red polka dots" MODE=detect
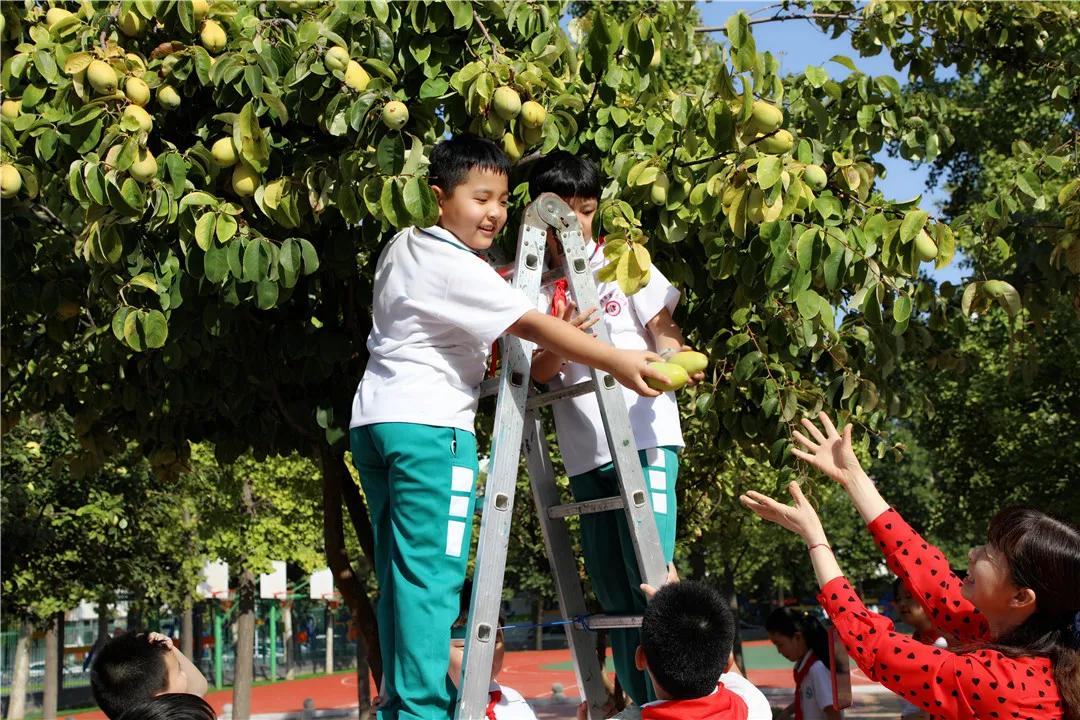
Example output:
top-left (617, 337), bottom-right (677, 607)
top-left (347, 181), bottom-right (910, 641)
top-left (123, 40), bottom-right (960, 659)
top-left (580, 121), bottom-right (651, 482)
top-left (986, 507), bottom-right (1080, 720)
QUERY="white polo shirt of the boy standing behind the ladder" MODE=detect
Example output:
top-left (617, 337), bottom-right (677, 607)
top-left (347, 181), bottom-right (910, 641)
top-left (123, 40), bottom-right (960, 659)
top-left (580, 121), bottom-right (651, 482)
top-left (540, 241), bottom-right (683, 475)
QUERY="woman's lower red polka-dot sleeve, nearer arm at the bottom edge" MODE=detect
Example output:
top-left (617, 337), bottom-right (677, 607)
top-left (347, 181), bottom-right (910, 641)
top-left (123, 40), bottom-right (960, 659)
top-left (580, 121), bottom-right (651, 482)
top-left (818, 576), bottom-right (1064, 720)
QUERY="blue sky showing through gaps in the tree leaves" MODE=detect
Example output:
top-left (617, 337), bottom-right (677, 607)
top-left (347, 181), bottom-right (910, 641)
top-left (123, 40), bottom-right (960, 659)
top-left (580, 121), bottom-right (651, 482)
top-left (698, 0), bottom-right (963, 284)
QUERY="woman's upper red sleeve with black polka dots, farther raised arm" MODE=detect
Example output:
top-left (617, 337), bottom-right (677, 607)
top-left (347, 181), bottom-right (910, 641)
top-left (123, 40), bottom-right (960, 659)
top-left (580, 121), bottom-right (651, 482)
top-left (866, 507), bottom-right (989, 642)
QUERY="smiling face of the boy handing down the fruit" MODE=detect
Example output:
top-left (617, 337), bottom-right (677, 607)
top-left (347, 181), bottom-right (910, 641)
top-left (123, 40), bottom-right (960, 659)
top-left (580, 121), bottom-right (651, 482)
top-left (432, 167), bottom-right (510, 250)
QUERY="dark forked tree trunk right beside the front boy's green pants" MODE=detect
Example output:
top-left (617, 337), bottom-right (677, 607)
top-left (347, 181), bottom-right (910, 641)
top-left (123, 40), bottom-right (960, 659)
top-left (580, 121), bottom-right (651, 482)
top-left (319, 443), bottom-right (382, 684)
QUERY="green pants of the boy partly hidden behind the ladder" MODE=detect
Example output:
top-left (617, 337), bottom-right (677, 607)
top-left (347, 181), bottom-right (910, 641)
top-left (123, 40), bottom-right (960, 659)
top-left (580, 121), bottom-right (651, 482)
top-left (570, 446), bottom-right (678, 706)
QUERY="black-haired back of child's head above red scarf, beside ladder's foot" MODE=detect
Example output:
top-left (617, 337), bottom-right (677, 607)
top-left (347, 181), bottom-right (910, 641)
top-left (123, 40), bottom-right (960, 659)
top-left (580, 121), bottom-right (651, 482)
top-left (636, 582), bottom-right (735, 699)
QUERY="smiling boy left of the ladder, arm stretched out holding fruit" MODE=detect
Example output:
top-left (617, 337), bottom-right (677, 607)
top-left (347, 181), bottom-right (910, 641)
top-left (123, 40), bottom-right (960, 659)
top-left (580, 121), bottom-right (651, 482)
top-left (350, 135), bottom-right (662, 720)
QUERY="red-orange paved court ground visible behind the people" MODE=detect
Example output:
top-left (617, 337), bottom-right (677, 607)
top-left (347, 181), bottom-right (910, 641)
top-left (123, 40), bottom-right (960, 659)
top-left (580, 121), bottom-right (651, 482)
top-left (67, 643), bottom-right (900, 720)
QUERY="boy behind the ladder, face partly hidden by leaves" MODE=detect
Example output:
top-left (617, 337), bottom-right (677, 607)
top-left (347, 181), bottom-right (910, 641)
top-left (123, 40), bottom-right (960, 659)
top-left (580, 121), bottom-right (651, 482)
top-left (529, 150), bottom-right (704, 705)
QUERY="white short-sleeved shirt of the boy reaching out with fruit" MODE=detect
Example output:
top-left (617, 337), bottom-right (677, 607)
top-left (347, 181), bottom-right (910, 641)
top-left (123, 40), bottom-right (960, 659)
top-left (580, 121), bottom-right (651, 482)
top-left (349, 226), bottom-right (535, 433)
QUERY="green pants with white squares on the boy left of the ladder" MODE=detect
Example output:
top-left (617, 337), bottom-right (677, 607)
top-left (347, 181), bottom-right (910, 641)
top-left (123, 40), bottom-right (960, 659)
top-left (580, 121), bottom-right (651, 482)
top-left (349, 422), bottom-right (478, 720)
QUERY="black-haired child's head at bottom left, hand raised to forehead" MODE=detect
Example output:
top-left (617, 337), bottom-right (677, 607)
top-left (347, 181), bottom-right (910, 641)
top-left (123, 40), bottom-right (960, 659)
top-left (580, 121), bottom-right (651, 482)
top-left (90, 633), bottom-right (188, 719)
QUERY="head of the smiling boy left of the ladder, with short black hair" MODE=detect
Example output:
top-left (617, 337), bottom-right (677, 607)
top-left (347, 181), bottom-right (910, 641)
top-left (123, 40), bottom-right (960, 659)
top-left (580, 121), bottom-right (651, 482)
top-left (428, 135), bottom-right (510, 250)
